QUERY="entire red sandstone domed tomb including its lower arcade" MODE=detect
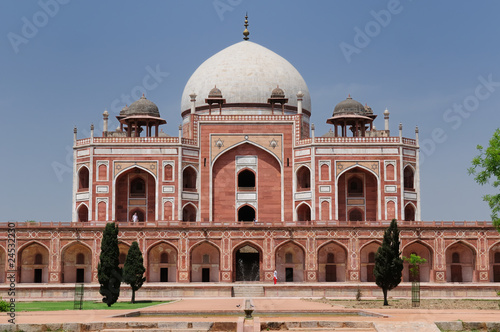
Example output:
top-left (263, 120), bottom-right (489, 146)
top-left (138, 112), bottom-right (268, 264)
top-left (0, 17), bottom-right (500, 297)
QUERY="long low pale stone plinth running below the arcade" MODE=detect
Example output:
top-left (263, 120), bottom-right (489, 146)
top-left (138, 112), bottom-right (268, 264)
top-left (0, 282), bottom-right (500, 301)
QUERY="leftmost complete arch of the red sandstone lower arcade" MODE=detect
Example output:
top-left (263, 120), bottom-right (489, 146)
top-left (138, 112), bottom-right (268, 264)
top-left (18, 242), bottom-right (49, 283)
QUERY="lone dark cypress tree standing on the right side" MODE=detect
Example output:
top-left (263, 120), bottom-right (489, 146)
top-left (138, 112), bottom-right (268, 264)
top-left (373, 219), bottom-right (403, 305)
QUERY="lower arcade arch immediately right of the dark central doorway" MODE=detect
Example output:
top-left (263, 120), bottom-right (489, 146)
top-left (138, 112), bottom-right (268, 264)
top-left (275, 241), bottom-right (305, 282)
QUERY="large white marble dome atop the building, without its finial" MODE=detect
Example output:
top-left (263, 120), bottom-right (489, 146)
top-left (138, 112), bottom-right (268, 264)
top-left (181, 41), bottom-right (311, 111)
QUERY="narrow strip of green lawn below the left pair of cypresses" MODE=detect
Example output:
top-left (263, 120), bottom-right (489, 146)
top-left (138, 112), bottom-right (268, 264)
top-left (16, 301), bottom-right (170, 312)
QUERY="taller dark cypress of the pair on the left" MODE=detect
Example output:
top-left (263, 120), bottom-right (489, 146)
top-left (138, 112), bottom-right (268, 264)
top-left (97, 223), bottom-right (122, 307)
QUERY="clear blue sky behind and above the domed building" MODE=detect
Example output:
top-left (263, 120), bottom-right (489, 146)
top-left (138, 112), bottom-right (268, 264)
top-left (0, 0), bottom-right (500, 221)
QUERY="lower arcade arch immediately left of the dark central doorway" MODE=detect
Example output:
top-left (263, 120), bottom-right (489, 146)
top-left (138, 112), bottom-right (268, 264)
top-left (190, 241), bottom-right (220, 282)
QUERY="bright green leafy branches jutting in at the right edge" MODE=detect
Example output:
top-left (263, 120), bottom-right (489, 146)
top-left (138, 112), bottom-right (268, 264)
top-left (468, 128), bottom-right (500, 231)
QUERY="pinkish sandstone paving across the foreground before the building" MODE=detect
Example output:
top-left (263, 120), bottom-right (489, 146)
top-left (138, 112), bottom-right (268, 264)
top-left (0, 298), bottom-right (500, 332)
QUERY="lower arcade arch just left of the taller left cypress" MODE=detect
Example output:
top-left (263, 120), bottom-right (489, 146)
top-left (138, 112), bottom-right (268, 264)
top-left (61, 242), bottom-right (92, 283)
